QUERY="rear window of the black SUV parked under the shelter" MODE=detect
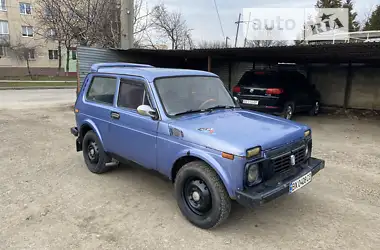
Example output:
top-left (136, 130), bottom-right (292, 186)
top-left (239, 71), bottom-right (281, 88)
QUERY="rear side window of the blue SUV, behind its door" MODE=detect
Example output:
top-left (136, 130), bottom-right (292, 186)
top-left (86, 76), bottom-right (116, 105)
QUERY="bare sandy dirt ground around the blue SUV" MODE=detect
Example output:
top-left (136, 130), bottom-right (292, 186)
top-left (0, 102), bottom-right (380, 250)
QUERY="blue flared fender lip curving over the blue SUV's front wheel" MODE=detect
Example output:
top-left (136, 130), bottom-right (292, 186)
top-left (172, 148), bottom-right (235, 198)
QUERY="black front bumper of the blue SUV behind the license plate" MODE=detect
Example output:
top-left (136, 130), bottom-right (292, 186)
top-left (236, 158), bottom-right (325, 207)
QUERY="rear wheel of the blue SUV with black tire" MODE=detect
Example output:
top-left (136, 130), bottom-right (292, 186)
top-left (83, 130), bottom-right (112, 174)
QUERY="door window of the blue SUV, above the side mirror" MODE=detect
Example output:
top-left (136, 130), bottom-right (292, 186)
top-left (117, 78), bottom-right (149, 109)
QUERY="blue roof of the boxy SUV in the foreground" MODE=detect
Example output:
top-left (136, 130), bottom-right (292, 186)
top-left (97, 67), bottom-right (217, 82)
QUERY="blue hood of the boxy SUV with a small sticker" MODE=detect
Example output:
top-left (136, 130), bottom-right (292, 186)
top-left (169, 109), bottom-right (308, 156)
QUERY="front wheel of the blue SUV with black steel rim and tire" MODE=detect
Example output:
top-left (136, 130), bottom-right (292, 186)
top-left (174, 161), bottom-right (231, 229)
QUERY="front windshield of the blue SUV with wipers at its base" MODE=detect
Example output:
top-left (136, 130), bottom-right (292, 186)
top-left (155, 76), bottom-right (236, 116)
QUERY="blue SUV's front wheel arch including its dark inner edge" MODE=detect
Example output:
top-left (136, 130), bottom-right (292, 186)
top-left (170, 149), bottom-right (234, 198)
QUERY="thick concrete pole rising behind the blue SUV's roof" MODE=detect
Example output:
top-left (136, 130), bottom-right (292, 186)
top-left (120, 0), bottom-right (134, 49)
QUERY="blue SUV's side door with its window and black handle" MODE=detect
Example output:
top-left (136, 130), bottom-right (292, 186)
top-left (109, 76), bottom-right (158, 169)
